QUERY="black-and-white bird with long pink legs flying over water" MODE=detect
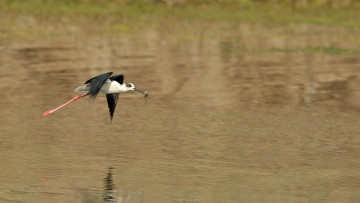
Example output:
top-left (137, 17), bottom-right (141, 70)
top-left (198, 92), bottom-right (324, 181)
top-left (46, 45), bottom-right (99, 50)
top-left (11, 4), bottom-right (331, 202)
top-left (41, 72), bottom-right (148, 121)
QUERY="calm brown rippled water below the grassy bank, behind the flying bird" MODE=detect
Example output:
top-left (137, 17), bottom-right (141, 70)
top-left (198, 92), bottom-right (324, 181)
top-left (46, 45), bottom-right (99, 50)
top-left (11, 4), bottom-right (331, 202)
top-left (0, 25), bottom-right (360, 203)
